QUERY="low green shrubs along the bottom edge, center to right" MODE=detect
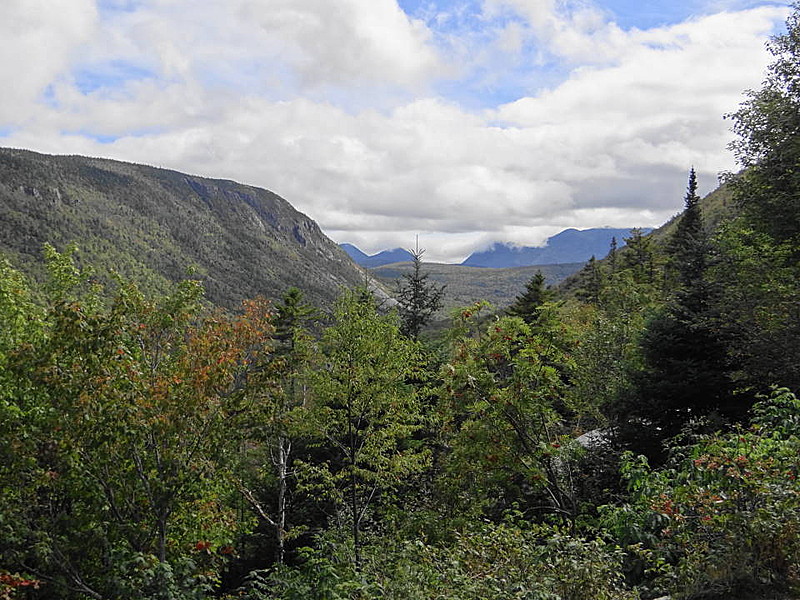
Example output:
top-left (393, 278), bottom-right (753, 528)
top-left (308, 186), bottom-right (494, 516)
top-left (233, 522), bottom-right (636, 600)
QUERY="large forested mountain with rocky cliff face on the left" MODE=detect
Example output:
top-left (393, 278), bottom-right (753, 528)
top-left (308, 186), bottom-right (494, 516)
top-left (0, 148), bottom-right (364, 308)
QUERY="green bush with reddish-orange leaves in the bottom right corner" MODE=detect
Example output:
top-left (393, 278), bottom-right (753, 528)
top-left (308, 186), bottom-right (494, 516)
top-left (608, 389), bottom-right (800, 598)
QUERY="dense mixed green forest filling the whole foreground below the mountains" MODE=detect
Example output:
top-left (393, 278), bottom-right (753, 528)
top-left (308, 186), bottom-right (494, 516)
top-left (0, 9), bottom-right (800, 600)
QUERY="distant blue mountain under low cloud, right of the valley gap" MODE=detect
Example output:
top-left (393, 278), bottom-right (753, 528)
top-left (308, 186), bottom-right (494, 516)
top-left (461, 227), bottom-right (650, 268)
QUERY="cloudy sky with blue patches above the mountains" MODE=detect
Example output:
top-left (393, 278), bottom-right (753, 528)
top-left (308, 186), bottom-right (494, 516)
top-left (0, 0), bottom-right (789, 262)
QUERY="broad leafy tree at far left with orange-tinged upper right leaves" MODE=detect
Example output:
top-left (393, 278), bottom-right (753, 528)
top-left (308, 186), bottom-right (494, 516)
top-left (0, 249), bottom-right (271, 598)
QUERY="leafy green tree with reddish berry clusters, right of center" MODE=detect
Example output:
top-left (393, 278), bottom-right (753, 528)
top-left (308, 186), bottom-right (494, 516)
top-left (438, 305), bottom-right (577, 519)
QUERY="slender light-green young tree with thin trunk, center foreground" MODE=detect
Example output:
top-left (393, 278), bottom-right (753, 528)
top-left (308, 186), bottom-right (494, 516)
top-left (310, 291), bottom-right (427, 566)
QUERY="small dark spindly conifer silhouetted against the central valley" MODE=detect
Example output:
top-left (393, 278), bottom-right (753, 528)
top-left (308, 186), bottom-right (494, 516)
top-left (396, 241), bottom-right (445, 339)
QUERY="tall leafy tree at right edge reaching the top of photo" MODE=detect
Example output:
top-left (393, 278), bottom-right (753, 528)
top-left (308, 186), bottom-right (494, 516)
top-left (713, 3), bottom-right (800, 391)
